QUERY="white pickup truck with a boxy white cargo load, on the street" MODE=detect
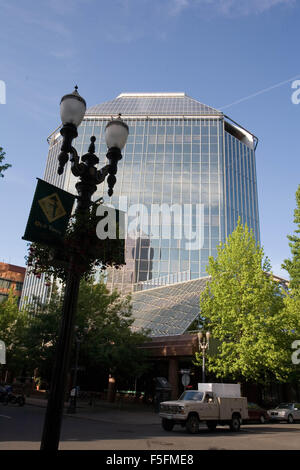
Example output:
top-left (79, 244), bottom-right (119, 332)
top-left (159, 383), bottom-right (248, 434)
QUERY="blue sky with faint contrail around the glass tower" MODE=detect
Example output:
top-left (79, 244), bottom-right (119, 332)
top-left (0, 0), bottom-right (300, 278)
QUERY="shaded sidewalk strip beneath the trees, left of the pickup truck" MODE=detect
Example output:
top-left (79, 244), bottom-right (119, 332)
top-left (25, 397), bottom-right (161, 425)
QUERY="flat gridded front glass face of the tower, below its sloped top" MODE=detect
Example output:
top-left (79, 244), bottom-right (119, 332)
top-left (65, 118), bottom-right (225, 289)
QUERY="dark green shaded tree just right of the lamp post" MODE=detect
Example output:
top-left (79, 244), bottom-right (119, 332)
top-left (76, 280), bottom-right (146, 386)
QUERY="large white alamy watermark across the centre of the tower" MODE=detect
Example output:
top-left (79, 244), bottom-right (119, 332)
top-left (96, 196), bottom-right (204, 251)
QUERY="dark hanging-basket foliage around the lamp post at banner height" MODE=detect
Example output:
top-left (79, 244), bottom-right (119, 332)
top-left (26, 204), bottom-right (125, 281)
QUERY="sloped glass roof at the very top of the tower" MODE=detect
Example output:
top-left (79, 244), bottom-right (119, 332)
top-left (86, 93), bottom-right (223, 116)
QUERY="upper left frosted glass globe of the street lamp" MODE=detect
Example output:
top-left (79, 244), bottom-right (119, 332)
top-left (60, 86), bottom-right (86, 127)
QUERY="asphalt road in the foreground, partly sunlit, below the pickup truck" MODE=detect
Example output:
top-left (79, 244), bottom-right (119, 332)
top-left (0, 405), bottom-right (300, 451)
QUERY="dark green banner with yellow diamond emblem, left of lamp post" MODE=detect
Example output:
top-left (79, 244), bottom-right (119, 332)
top-left (22, 178), bottom-right (75, 246)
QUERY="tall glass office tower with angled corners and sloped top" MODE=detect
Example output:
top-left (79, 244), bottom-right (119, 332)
top-left (21, 93), bottom-right (259, 302)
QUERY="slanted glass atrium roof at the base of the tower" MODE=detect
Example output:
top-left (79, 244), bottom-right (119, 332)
top-left (132, 277), bottom-right (209, 336)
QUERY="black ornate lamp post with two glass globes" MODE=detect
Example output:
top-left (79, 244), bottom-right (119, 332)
top-left (41, 86), bottom-right (129, 451)
